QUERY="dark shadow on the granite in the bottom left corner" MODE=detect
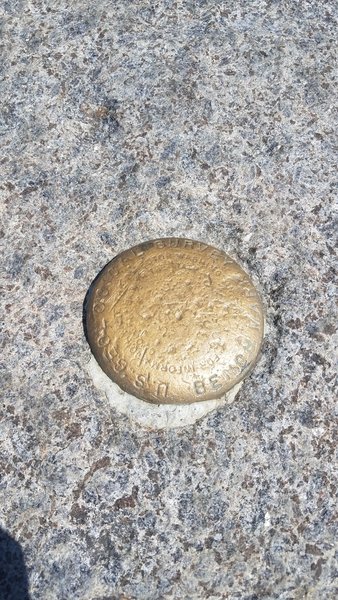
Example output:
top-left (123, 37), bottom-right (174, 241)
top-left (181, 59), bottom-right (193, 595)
top-left (0, 528), bottom-right (30, 600)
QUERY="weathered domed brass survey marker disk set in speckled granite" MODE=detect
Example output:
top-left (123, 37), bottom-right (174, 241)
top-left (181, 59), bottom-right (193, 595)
top-left (86, 238), bottom-right (264, 404)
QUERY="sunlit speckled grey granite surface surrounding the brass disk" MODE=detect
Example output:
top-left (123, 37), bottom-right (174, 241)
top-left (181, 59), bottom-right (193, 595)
top-left (0, 0), bottom-right (337, 600)
